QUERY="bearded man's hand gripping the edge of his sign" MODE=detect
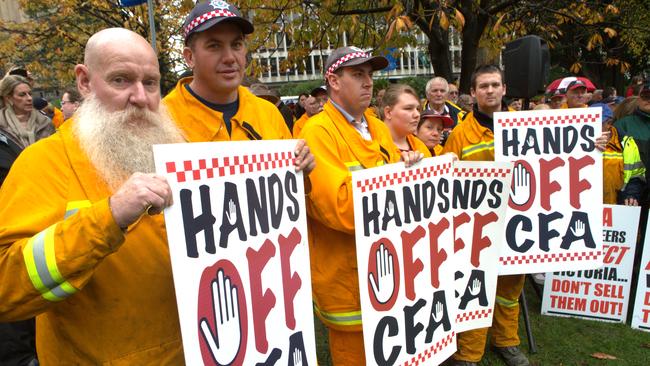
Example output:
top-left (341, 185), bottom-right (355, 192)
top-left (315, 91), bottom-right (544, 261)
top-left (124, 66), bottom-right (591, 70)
top-left (109, 173), bottom-right (172, 228)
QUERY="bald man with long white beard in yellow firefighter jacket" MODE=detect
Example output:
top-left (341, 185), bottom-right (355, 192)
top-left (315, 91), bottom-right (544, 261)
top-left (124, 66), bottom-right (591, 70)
top-left (0, 28), bottom-right (184, 365)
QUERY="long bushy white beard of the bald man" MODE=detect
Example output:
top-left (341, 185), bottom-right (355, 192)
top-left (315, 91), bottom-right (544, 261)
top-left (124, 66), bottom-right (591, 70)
top-left (74, 95), bottom-right (186, 192)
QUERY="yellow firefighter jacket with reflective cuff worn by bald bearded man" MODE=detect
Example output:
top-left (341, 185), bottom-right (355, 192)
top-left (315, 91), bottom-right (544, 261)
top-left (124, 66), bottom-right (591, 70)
top-left (0, 119), bottom-right (183, 365)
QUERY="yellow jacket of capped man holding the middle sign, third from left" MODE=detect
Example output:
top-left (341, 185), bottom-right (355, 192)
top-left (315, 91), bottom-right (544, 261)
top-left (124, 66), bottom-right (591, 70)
top-left (301, 102), bottom-right (400, 331)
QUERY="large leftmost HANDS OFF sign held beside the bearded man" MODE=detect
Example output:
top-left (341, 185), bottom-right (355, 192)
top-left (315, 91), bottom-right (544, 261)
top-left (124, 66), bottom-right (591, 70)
top-left (154, 140), bottom-right (316, 366)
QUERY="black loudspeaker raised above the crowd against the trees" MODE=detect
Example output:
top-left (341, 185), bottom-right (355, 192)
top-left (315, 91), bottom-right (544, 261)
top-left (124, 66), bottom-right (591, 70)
top-left (503, 36), bottom-right (551, 98)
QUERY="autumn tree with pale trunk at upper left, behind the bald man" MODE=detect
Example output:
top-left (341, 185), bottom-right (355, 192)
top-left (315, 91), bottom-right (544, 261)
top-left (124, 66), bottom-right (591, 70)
top-left (0, 0), bottom-right (194, 94)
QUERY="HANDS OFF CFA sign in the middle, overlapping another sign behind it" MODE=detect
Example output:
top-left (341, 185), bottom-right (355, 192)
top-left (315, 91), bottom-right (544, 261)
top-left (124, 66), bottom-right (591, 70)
top-left (352, 156), bottom-right (456, 365)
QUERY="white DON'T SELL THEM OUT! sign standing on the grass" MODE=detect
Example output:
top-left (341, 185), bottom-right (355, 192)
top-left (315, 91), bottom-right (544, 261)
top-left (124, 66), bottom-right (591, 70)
top-left (542, 205), bottom-right (641, 323)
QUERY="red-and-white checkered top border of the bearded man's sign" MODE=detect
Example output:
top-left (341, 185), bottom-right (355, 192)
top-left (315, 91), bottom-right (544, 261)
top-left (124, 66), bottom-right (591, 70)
top-left (165, 151), bottom-right (294, 183)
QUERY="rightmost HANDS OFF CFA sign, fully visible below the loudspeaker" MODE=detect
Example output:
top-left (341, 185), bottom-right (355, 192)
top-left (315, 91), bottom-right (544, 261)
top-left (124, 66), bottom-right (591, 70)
top-left (494, 108), bottom-right (603, 274)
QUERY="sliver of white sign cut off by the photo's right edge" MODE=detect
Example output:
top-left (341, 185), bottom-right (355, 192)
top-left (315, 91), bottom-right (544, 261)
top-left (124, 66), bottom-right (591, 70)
top-left (632, 214), bottom-right (650, 332)
